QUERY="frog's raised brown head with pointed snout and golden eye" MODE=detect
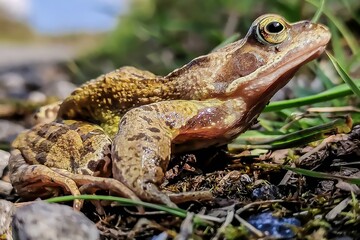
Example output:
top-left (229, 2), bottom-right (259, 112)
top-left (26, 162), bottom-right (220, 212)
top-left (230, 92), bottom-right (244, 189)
top-left (218, 14), bottom-right (331, 103)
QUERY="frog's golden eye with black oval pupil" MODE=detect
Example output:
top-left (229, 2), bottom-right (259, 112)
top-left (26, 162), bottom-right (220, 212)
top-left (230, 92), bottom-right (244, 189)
top-left (256, 16), bottom-right (288, 44)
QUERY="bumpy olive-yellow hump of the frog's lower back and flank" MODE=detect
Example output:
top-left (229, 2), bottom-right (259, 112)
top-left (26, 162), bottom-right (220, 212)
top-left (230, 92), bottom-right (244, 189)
top-left (58, 67), bottom-right (176, 136)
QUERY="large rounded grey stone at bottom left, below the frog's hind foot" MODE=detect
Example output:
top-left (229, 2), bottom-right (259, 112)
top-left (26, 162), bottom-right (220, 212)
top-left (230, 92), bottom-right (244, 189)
top-left (12, 201), bottom-right (100, 240)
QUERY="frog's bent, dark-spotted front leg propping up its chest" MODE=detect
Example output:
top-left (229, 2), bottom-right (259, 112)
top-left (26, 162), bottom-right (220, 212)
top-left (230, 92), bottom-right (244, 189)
top-left (112, 99), bottom-right (246, 206)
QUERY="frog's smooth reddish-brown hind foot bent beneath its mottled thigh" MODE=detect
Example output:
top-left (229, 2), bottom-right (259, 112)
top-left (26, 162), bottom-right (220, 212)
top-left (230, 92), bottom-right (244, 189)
top-left (9, 149), bottom-right (83, 210)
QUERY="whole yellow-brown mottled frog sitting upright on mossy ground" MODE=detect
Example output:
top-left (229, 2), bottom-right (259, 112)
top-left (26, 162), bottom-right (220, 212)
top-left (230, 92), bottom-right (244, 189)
top-left (10, 14), bottom-right (330, 207)
